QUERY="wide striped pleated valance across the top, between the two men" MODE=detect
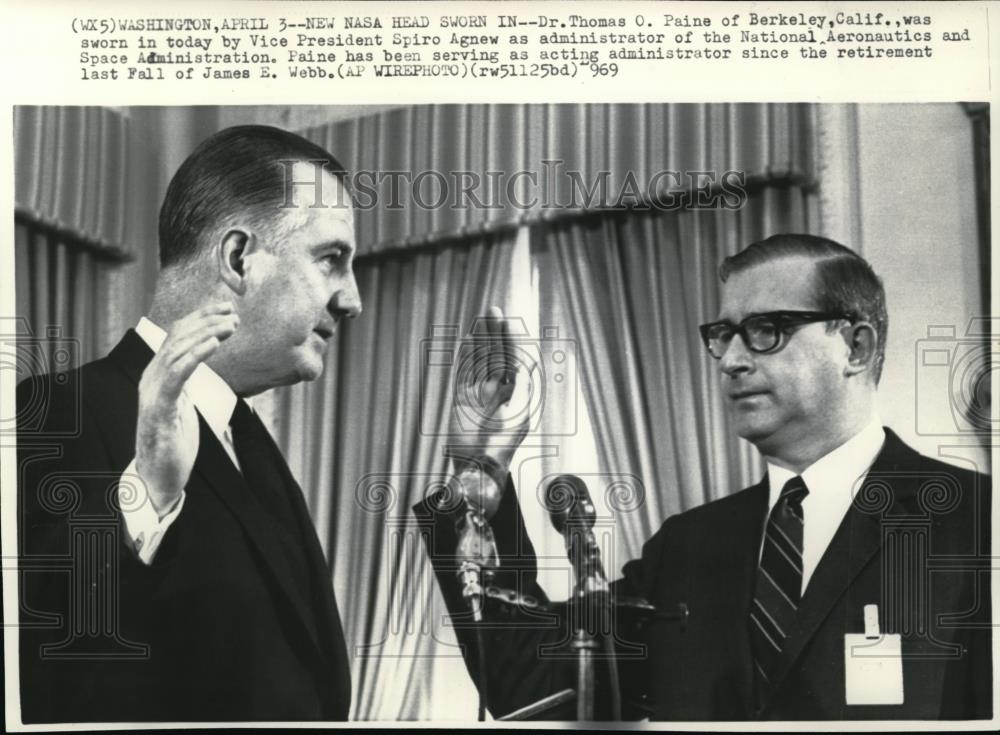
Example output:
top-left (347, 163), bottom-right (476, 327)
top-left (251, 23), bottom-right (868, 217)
top-left (303, 103), bottom-right (814, 253)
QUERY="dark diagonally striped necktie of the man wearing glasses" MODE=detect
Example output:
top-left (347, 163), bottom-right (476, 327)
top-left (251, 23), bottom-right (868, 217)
top-left (750, 477), bottom-right (809, 695)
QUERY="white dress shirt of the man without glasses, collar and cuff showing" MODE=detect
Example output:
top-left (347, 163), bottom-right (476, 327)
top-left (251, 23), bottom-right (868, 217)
top-left (118, 317), bottom-right (240, 564)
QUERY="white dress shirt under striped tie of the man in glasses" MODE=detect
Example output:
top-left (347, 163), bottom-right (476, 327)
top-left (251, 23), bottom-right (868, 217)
top-left (761, 414), bottom-right (885, 594)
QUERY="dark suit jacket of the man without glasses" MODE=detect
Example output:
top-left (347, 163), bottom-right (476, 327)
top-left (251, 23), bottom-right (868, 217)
top-left (18, 331), bottom-right (351, 722)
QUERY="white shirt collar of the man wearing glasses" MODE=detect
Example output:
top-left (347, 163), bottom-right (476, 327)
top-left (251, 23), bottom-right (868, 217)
top-left (767, 413), bottom-right (885, 508)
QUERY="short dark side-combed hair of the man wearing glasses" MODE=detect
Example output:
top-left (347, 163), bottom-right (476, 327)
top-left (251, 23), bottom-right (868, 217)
top-left (719, 234), bottom-right (889, 384)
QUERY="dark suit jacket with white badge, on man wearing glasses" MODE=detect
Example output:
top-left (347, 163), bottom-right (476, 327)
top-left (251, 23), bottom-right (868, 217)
top-left (417, 430), bottom-right (992, 720)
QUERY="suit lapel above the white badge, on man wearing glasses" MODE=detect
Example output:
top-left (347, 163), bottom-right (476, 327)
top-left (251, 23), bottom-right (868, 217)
top-left (771, 429), bottom-right (919, 692)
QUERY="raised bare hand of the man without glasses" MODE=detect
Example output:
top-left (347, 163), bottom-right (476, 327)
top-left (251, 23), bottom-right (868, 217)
top-left (135, 301), bottom-right (239, 517)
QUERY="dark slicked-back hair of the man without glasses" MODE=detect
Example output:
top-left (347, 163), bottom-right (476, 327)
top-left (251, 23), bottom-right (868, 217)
top-left (160, 125), bottom-right (346, 267)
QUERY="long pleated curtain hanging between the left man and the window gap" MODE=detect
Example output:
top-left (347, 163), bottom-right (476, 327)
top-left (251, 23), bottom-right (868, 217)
top-left (276, 232), bottom-right (528, 720)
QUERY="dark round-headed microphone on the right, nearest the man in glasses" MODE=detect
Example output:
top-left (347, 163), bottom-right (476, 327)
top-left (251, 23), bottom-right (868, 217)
top-left (543, 475), bottom-right (608, 594)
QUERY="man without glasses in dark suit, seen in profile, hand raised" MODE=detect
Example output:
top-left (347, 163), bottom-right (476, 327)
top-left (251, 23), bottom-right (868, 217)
top-left (18, 126), bottom-right (361, 722)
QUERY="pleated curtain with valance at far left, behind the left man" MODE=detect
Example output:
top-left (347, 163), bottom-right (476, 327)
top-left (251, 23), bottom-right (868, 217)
top-left (14, 107), bottom-right (135, 379)
